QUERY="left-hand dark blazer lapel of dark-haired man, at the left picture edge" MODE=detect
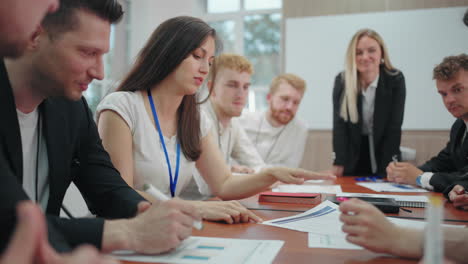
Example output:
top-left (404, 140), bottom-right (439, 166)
top-left (0, 60), bottom-right (23, 183)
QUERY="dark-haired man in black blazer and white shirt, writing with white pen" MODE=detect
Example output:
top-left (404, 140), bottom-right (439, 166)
top-left (0, 0), bottom-right (200, 253)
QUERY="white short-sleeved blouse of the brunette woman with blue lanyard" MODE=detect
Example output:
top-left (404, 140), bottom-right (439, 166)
top-left (96, 92), bottom-right (211, 197)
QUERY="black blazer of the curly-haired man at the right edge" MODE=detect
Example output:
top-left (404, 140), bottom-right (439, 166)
top-left (419, 119), bottom-right (468, 193)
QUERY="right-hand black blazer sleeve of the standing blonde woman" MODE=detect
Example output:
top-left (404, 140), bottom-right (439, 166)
top-left (378, 72), bottom-right (406, 173)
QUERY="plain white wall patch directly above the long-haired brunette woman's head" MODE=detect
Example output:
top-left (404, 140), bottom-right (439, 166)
top-left (129, 0), bottom-right (199, 62)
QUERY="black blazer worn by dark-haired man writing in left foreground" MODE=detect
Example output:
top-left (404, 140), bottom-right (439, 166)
top-left (0, 62), bottom-right (144, 253)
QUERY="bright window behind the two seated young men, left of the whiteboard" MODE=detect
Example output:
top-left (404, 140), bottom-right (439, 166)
top-left (199, 0), bottom-right (282, 111)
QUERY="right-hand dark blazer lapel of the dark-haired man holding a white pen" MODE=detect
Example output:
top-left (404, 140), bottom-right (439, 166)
top-left (41, 99), bottom-right (69, 212)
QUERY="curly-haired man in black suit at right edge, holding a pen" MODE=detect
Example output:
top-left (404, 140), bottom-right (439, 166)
top-left (387, 54), bottom-right (468, 196)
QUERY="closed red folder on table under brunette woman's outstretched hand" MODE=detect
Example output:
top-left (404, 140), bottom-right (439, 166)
top-left (258, 192), bottom-right (322, 204)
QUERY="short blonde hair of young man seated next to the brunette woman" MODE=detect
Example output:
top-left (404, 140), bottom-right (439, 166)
top-left (208, 53), bottom-right (254, 81)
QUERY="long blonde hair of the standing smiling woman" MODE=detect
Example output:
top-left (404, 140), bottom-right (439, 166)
top-left (340, 28), bottom-right (398, 123)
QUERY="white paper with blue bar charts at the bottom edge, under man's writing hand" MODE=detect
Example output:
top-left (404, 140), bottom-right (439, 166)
top-left (112, 236), bottom-right (284, 264)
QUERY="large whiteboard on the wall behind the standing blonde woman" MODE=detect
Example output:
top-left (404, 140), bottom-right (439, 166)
top-left (285, 7), bottom-right (468, 130)
